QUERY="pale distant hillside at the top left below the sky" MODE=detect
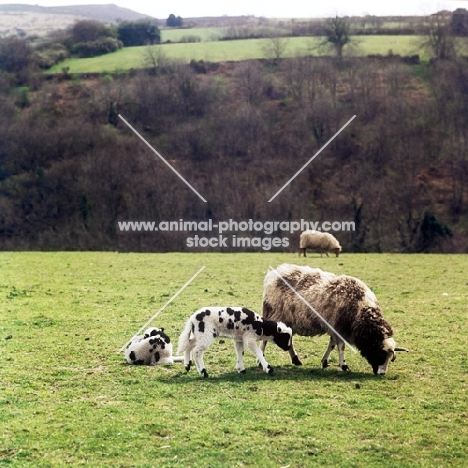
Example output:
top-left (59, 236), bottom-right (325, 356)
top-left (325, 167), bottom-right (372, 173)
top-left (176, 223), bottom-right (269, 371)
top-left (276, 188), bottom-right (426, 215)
top-left (0, 4), bottom-right (154, 37)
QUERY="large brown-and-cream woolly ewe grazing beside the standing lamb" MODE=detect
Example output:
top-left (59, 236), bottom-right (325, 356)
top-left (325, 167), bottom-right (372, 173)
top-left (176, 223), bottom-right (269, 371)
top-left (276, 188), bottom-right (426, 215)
top-left (261, 264), bottom-right (408, 375)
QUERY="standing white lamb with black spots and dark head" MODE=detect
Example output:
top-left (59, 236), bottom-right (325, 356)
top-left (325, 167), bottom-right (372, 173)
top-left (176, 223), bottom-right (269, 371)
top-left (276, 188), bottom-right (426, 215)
top-left (177, 307), bottom-right (292, 378)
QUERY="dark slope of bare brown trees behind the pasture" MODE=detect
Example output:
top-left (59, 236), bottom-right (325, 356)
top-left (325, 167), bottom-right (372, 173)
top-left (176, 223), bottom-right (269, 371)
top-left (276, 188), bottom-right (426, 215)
top-left (0, 50), bottom-right (468, 252)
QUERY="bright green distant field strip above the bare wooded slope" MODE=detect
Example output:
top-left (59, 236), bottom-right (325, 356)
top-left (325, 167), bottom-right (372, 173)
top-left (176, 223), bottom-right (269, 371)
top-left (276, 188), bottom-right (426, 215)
top-left (48, 34), bottom-right (424, 73)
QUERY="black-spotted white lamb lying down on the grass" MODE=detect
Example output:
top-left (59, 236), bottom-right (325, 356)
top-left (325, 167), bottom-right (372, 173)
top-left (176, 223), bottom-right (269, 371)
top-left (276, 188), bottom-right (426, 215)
top-left (125, 327), bottom-right (182, 366)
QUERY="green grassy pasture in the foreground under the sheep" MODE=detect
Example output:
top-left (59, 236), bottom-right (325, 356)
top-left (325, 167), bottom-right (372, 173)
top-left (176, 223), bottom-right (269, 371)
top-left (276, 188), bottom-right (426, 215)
top-left (0, 252), bottom-right (468, 468)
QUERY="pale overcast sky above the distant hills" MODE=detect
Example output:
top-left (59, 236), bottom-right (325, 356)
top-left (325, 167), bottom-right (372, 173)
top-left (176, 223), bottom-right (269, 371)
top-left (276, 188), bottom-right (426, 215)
top-left (0, 0), bottom-right (468, 19)
